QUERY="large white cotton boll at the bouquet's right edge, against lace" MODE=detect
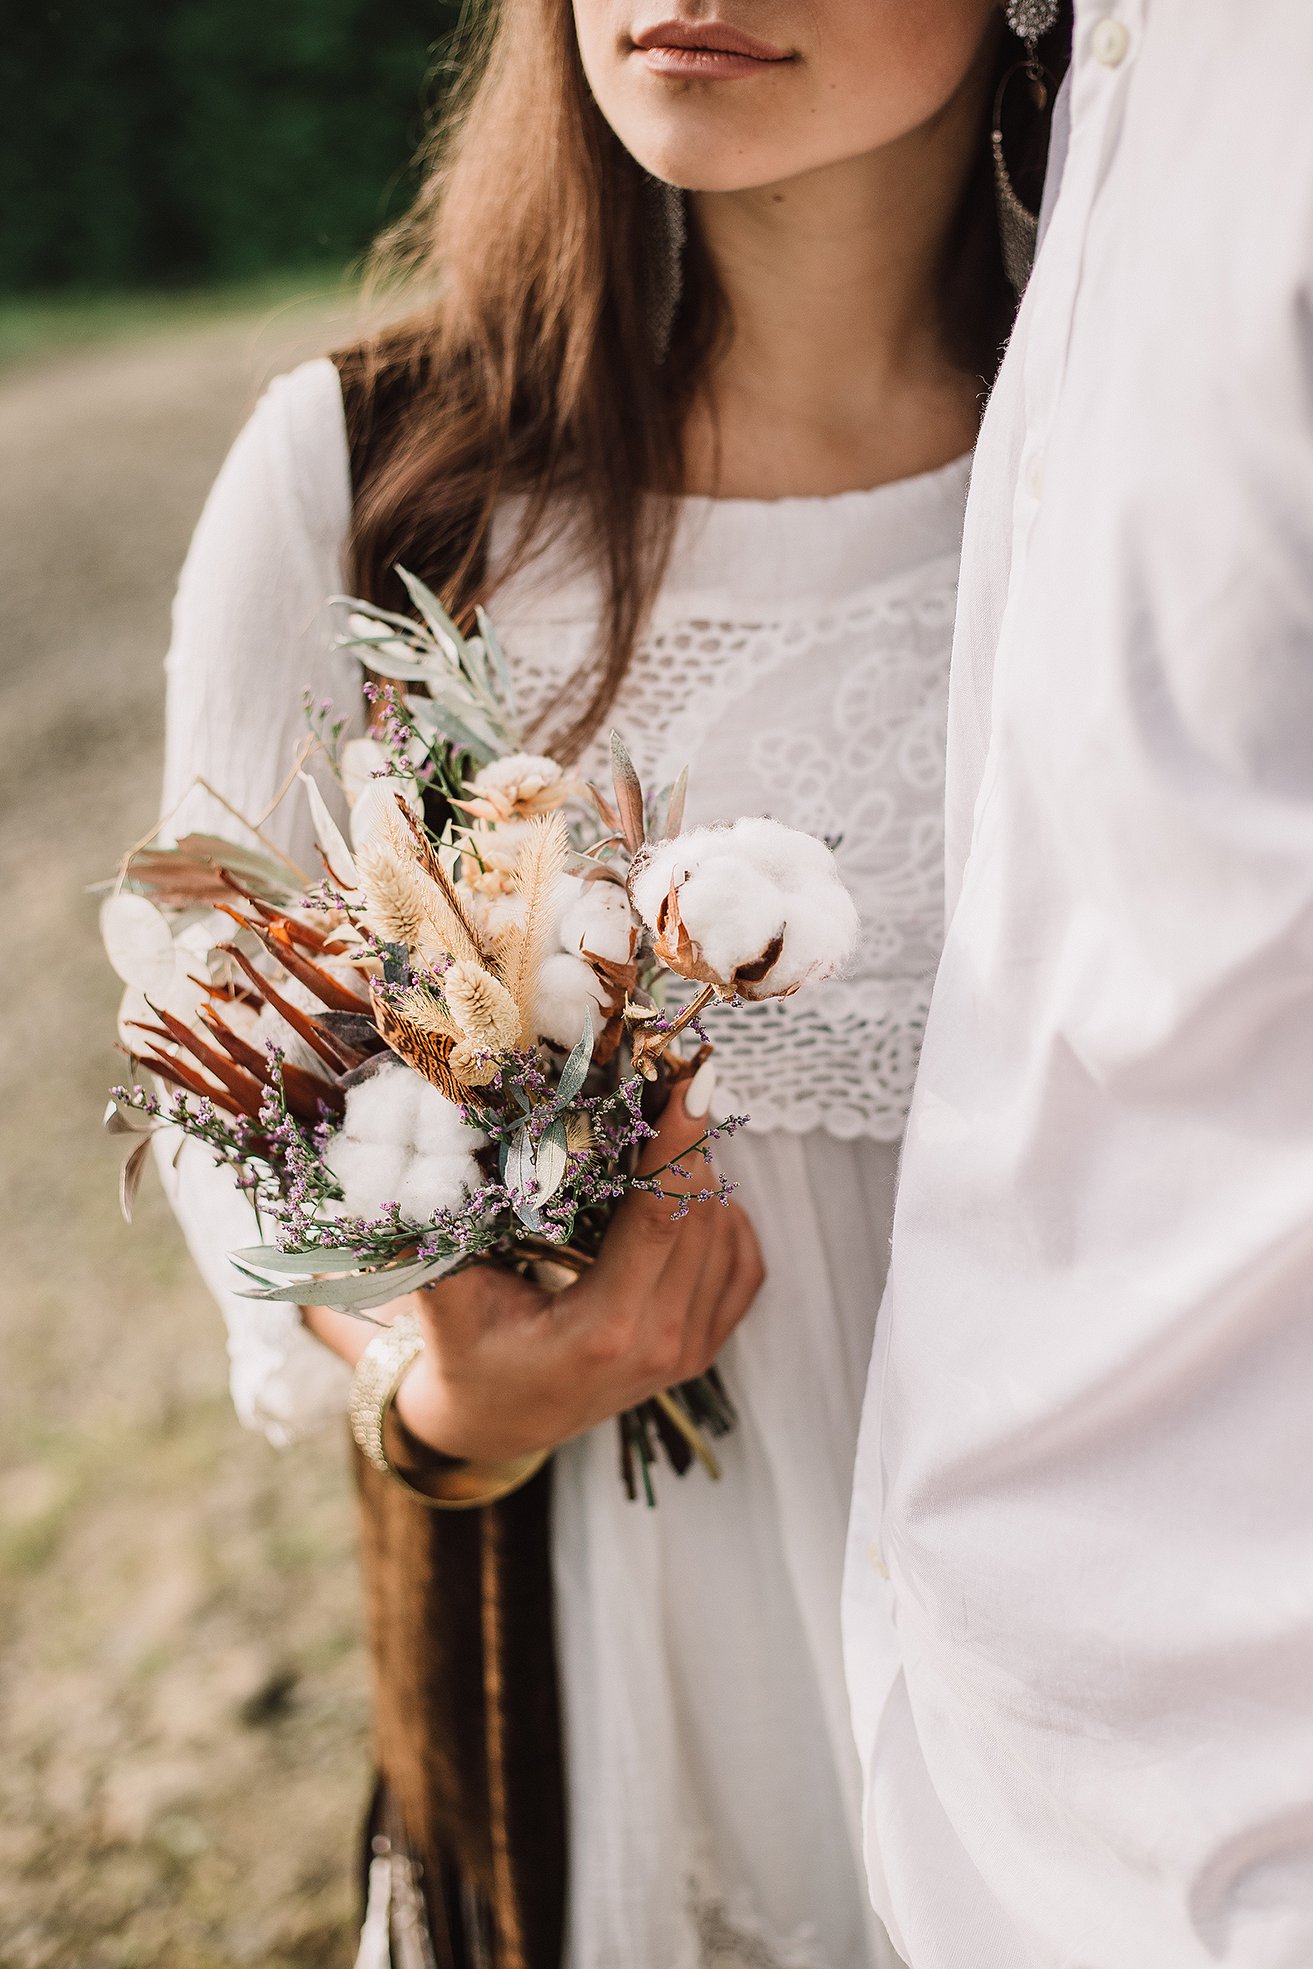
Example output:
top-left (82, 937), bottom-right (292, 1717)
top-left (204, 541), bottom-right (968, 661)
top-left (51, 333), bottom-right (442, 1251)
top-left (630, 819), bottom-right (860, 998)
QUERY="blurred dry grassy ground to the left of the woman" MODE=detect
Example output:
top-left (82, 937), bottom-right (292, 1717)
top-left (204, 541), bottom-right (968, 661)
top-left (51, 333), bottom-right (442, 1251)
top-left (0, 285), bottom-right (385, 1969)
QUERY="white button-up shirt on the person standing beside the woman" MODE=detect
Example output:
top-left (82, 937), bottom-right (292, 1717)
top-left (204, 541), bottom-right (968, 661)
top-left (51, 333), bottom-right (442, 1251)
top-left (846, 0), bottom-right (1313, 1969)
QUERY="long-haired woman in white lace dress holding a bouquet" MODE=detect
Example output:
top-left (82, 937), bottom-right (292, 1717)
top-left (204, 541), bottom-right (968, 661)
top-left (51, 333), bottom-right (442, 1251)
top-left (156, 0), bottom-right (1061, 1969)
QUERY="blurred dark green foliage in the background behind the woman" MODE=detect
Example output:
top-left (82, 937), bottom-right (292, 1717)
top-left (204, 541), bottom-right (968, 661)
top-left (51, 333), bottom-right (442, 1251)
top-left (0, 0), bottom-right (457, 293)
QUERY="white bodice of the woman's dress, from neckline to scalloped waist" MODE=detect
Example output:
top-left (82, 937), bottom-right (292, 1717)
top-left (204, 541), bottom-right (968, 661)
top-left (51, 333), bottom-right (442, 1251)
top-left (492, 461), bottom-right (967, 1140)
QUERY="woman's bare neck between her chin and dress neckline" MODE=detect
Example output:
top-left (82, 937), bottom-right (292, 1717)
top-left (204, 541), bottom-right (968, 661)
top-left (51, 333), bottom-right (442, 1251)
top-left (687, 89), bottom-right (980, 498)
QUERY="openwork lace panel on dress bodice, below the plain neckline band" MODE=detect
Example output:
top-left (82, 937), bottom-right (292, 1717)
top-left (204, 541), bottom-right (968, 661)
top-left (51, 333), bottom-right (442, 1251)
top-left (508, 557), bottom-right (957, 1142)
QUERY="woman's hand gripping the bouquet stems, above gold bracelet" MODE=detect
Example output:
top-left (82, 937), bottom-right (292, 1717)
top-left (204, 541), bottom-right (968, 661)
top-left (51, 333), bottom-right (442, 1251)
top-left (305, 1093), bottom-right (764, 1463)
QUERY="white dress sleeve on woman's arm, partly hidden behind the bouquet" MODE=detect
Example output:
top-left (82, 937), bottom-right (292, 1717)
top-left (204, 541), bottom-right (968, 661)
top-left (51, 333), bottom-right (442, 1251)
top-left (156, 360), bottom-right (362, 1443)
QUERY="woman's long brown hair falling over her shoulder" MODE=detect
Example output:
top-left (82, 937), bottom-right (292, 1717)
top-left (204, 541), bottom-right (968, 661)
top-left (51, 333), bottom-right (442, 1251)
top-left (352, 0), bottom-right (1063, 754)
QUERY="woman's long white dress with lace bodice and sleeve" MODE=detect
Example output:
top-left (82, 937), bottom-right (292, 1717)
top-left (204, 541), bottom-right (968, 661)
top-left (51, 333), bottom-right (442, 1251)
top-left (156, 362), bottom-right (967, 1969)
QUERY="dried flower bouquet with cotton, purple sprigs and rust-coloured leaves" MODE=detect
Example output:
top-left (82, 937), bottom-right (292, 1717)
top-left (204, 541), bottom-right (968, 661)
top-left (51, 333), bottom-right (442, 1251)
top-left (102, 573), bottom-right (856, 1502)
